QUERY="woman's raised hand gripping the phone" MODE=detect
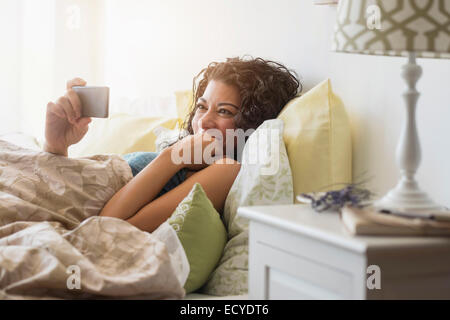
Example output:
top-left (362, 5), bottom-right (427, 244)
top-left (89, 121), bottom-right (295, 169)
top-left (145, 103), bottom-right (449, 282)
top-left (44, 78), bottom-right (91, 156)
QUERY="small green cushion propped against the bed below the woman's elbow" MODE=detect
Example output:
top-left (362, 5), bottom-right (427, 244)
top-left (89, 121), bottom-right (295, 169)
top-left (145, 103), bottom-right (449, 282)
top-left (167, 183), bottom-right (227, 293)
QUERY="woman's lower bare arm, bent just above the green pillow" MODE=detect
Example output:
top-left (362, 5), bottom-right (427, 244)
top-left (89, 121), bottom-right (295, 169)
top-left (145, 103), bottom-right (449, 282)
top-left (126, 159), bottom-right (241, 232)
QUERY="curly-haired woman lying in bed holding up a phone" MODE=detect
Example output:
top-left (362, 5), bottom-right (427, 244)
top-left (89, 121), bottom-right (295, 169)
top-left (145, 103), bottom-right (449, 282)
top-left (44, 58), bottom-right (301, 232)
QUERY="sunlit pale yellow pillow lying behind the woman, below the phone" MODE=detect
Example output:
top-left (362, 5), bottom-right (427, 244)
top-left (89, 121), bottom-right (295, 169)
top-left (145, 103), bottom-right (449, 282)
top-left (69, 113), bottom-right (180, 157)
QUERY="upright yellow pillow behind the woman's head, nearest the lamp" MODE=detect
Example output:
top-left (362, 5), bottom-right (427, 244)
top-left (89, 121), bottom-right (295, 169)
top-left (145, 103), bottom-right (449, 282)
top-left (278, 79), bottom-right (352, 203)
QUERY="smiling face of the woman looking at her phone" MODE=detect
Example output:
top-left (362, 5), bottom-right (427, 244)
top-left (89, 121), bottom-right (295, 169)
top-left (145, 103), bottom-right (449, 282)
top-left (192, 80), bottom-right (241, 151)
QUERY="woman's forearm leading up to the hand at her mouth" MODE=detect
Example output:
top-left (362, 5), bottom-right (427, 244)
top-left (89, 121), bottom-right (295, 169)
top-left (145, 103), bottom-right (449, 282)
top-left (99, 148), bottom-right (183, 220)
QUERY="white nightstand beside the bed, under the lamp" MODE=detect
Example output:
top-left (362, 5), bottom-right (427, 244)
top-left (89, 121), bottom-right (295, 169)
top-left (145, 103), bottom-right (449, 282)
top-left (238, 205), bottom-right (450, 299)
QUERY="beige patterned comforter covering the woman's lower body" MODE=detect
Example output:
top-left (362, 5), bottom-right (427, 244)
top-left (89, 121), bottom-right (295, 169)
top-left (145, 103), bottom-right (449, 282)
top-left (0, 140), bottom-right (188, 299)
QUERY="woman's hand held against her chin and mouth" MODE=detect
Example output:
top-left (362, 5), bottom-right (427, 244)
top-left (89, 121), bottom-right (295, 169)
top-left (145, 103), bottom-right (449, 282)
top-left (168, 132), bottom-right (223, 171)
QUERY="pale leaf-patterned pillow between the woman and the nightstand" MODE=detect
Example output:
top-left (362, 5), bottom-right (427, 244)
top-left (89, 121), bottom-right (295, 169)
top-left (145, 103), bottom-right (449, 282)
top-left (201, 119), bottom-right (293, 296)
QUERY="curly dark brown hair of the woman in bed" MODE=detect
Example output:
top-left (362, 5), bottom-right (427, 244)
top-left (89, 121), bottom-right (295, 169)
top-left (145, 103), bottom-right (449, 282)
top-left (182, 56), bottom-right (302, 134)
